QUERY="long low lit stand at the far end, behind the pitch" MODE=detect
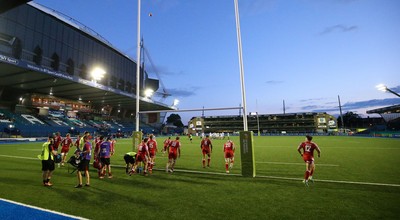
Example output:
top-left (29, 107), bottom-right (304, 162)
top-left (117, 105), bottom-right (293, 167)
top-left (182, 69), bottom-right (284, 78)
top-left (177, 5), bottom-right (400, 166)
top-left (188, 112), bottom-right (338, 134)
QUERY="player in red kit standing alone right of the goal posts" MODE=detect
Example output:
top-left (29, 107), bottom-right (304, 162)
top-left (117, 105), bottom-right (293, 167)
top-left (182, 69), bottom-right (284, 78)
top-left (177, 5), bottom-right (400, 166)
top-left (297, 135), bottom-right (321, 186)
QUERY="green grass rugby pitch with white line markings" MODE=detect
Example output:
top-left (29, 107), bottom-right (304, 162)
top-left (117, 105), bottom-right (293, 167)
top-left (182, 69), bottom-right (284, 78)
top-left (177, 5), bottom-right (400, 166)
top-left (0, 137), bottom-right (400, 219)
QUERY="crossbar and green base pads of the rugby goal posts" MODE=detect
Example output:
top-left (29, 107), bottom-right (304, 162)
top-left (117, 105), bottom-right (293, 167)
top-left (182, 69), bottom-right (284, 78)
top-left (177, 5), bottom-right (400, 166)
top-left (137, 107), bottom-right (256, 177)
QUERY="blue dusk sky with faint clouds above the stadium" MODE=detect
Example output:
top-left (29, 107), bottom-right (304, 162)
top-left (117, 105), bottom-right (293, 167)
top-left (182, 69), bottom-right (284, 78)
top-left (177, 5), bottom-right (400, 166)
top-left (34, 0), bottom-right (400, 124)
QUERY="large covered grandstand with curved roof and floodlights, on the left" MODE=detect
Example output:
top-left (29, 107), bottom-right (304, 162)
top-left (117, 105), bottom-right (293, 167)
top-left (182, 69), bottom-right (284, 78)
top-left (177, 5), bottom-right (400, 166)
top-left (0, 0), bottom-right (171, 136)
